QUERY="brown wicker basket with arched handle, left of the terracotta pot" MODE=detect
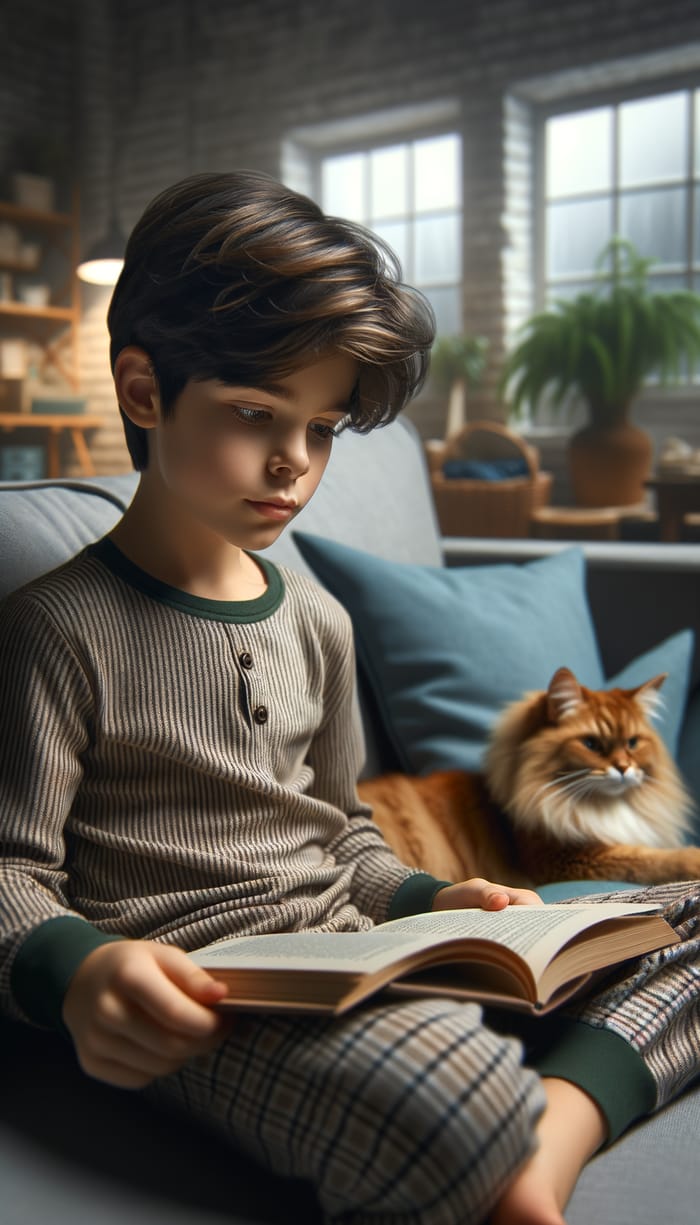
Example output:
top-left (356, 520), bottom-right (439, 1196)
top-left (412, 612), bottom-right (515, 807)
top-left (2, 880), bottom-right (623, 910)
top-left (427, 421), bottom-right (553, 538)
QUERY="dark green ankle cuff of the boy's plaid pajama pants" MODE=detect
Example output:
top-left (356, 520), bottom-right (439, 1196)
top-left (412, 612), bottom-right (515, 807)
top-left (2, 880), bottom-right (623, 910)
top-left (528, 1019), bottom-right (656, 1144)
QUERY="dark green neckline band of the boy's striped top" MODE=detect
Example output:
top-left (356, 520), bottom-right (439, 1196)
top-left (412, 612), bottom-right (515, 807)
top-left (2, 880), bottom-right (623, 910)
top-left (86, 537), bottom-right (284, 622)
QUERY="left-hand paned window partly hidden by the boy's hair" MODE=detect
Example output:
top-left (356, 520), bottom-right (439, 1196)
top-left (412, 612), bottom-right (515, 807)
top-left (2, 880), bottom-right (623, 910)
top-left (318, 132), bottom-right (462, 336)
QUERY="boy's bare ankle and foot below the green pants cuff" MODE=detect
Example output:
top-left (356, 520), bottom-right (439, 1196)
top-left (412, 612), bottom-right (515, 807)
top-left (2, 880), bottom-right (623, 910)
top-left (489, 1077), bottom-right (607, 1225)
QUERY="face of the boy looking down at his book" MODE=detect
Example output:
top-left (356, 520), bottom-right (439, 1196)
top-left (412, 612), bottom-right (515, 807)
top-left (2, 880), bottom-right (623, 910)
top-left (145, 354), bottom-right (359, 550)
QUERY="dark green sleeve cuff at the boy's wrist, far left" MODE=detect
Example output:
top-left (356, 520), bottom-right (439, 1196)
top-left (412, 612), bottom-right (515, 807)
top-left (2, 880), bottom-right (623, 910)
top-left (10, 915), bottom-right (123, 1031)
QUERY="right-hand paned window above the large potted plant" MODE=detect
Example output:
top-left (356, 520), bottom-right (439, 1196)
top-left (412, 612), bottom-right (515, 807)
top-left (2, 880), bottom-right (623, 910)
top-left (538, 88), bottom-right (700, 301)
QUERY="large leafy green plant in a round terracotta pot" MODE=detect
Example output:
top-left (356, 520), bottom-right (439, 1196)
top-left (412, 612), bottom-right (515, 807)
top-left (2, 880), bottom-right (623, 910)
top-left (501, 238), bottom-right (700, 506)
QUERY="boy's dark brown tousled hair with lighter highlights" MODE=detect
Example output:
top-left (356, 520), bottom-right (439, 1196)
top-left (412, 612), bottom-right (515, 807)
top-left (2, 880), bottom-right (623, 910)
top-left (108, 170), bottom-right (434, 469)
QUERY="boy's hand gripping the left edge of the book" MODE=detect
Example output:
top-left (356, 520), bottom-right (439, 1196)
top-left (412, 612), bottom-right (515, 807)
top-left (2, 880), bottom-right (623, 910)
top-left (63, 940), bottom-right (232, 1089)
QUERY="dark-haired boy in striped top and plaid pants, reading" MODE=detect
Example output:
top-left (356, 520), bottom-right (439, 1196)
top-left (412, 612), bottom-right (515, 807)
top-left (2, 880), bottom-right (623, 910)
top-left (0, 173), bottom-right (698, 1225)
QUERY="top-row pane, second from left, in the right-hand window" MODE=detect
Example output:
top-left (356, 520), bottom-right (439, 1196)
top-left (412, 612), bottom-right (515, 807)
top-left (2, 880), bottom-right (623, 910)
top-left (620, 92), bottom-right (688, 187)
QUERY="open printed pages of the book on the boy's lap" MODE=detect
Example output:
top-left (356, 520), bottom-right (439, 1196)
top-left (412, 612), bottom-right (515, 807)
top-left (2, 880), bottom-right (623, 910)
top-left (190, 902), bottom-right (658, 976)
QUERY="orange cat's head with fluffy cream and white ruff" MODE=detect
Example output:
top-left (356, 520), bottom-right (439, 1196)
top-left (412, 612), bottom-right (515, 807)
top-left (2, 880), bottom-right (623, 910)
top-left (487, 668), bottom-right (687, 845)
